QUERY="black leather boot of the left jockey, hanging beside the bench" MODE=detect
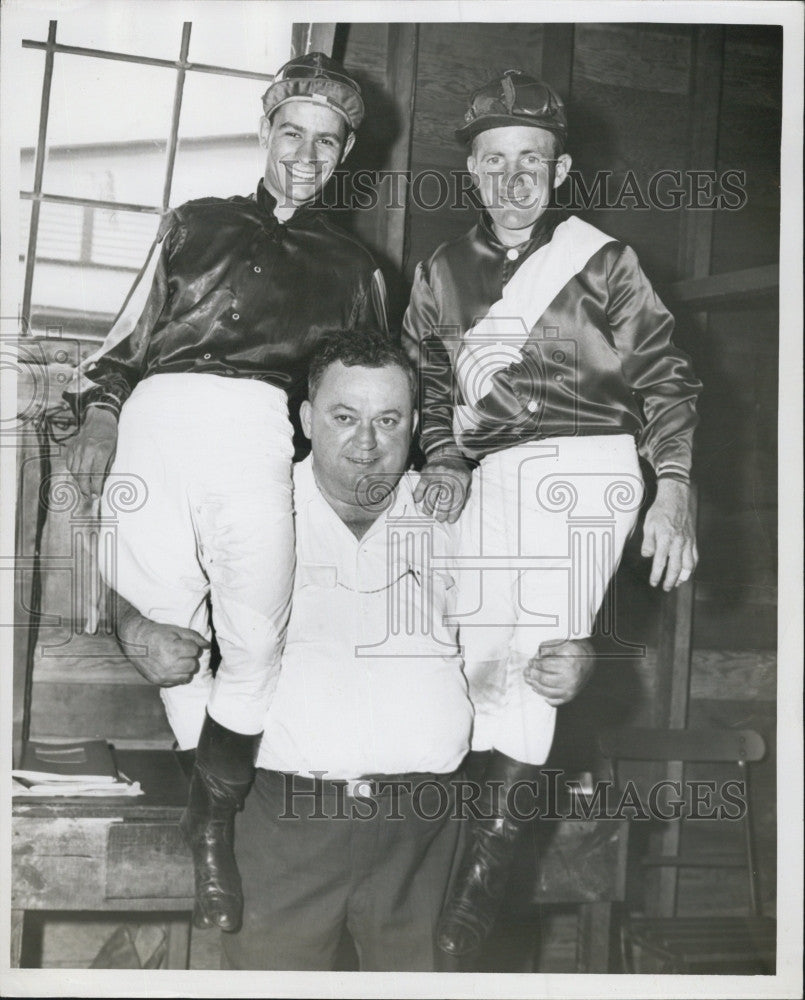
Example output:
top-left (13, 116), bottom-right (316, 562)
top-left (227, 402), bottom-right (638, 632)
top-left (179, 715), bottom-right (260, 933)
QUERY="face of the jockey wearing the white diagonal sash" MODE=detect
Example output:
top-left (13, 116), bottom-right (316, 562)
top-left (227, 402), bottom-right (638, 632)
top-left (467, 125), bottom-right (571, 243)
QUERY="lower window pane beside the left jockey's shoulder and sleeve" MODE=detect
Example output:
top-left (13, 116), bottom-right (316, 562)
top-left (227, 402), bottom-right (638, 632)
top-left (26, 202), bottom-right (159, 336)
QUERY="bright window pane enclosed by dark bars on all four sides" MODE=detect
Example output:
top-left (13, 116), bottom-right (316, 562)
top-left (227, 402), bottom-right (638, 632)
top-left (42, 53), bottom-right (176, 206)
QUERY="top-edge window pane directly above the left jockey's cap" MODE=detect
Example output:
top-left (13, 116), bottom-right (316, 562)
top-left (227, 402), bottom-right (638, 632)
top-left (190, 8), bottom-right (291, 73)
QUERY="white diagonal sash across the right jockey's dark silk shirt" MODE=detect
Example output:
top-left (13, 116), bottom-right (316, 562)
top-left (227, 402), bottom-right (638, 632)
top-left (453, 216), bottom-right (612, 443)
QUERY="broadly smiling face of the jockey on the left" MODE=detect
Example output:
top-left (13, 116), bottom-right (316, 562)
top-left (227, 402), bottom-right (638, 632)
top-left (260, 100), bottom-right (355, 207)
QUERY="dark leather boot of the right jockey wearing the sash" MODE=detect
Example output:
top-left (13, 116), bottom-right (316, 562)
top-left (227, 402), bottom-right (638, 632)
top-left (437, 750), bottom-right (541, 957)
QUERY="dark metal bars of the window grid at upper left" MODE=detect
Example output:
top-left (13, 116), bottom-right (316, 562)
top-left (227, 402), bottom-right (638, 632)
top-left (20, 21), bottom-right (274, 329)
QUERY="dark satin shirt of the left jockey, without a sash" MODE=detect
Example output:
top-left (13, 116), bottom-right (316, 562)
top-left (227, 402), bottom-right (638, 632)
top-left (66, 181), bottom-right (388, 412)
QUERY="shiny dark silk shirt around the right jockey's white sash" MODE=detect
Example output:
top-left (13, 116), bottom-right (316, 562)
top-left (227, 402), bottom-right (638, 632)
top-left (403, 213), bottom-right (701, 481)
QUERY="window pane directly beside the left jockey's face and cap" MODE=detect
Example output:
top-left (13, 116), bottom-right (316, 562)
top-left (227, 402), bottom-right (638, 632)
top-left (170, 73), bottom-right (265, 205)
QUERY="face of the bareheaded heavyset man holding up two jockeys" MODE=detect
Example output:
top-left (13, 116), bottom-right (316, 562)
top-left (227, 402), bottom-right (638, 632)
top-left (300, 361), bottom-right (417, 506)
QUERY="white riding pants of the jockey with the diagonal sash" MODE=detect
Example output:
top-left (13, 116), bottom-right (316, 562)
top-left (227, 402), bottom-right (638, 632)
top-left (457, 435), bottom-right (643, 764)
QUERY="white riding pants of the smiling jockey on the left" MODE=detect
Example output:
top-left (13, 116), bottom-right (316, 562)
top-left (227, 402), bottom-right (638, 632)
top-left (101, 374), bottom-right (295, 749)
